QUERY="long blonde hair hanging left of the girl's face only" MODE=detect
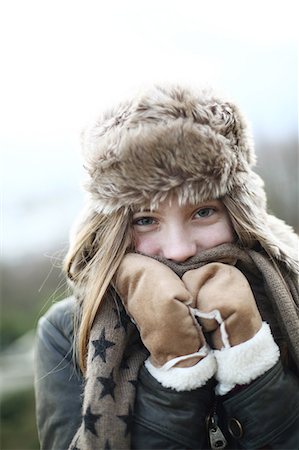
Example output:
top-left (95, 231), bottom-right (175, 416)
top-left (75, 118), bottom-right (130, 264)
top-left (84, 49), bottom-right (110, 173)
top-left (64, 209), bottom-right (132, 373)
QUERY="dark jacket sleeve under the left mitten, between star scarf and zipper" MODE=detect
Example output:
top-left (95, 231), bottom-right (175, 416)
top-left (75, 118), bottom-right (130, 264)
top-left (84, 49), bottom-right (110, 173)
top-left (132, 366), bottom-right (214, 450)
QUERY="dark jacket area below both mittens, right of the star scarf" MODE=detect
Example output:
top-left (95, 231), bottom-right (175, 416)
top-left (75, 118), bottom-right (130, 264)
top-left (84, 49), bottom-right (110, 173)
top-left (132, 362), bottom-right (299, 450)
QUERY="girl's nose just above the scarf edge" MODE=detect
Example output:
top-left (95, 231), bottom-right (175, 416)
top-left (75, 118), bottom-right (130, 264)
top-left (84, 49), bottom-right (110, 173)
top-left (162, 231), bottom-right (197, 262)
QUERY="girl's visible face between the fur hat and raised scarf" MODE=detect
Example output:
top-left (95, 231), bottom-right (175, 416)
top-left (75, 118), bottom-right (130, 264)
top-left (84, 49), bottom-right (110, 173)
top-left (133, 200), bottom-right (234, 262)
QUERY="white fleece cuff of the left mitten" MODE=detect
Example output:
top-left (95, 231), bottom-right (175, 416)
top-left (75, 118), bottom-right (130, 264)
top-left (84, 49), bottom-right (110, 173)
top-left (144, 351), bottom-right (217, 391)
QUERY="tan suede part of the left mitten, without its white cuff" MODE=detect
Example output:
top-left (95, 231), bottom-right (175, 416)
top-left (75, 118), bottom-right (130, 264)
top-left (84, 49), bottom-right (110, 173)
top-left (114, 253), bottom-right (204, 367)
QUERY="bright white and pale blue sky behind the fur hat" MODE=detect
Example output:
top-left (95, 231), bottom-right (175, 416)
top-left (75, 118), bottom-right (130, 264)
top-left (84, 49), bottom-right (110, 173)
top-left (0, 0), bottom-right (298, 258)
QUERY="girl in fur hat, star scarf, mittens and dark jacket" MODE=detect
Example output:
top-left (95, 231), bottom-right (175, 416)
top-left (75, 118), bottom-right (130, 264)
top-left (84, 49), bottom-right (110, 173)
top-left (36, 82), bottom-right (299, 450)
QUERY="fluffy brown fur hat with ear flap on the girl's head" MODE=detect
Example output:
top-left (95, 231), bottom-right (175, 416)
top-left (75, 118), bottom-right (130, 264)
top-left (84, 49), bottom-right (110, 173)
top-left (82, 86), bottom-right (298, 268)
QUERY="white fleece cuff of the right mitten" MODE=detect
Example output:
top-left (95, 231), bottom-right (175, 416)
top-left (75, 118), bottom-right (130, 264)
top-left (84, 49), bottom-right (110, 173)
top-left (213, 322), bottom-right (279, 395)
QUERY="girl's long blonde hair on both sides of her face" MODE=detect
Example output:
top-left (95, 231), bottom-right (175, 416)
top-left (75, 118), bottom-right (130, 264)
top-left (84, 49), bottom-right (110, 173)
top-left (64, 195), bottom-right (298, 373)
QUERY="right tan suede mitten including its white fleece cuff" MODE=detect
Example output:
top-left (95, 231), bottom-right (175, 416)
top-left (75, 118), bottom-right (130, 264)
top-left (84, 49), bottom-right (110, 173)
top-left (182, 263), bottom-right (279, 395)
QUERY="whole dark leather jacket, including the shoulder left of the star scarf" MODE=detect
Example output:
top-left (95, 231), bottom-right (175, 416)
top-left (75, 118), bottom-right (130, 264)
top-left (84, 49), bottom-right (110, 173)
top-left (35, 298), bottom-right (299, 450)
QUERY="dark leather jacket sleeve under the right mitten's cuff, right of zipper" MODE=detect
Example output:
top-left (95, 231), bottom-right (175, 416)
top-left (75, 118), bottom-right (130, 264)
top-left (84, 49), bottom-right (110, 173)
top-left (223, 361), bottom-right (299, 450)
